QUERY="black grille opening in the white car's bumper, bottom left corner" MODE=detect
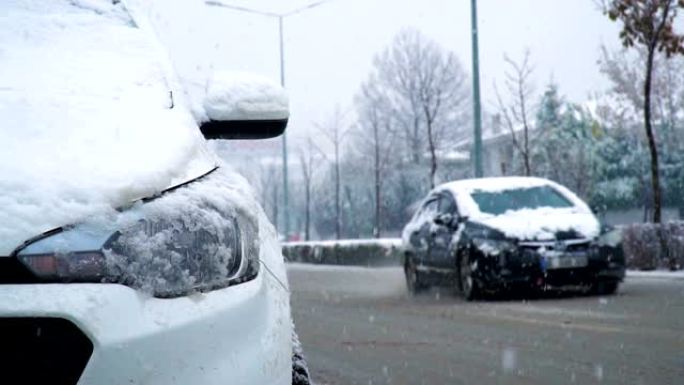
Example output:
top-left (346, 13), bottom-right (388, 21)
top-left (0, 318), bottom-right (93, 385)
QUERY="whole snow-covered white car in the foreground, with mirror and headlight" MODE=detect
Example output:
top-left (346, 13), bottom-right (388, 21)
top-left (0, 0), bottom-right (306, 385)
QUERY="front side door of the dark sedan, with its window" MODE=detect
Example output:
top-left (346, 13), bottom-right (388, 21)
top-left (426, 192), bottom-right (458, 268)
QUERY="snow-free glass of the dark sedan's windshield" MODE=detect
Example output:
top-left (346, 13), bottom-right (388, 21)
top-left (470, 186), bottom-right (573, 215)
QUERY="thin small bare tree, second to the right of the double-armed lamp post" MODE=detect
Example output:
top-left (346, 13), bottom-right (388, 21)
top-left (316, 106), bottom-right (347, 239)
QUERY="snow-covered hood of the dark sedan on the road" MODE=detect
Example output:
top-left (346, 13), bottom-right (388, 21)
top-left (476, 208), bottom-right (601, 241)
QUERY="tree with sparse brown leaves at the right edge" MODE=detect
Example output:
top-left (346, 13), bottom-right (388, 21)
top-left (604, 0), bottom-right (684, 223)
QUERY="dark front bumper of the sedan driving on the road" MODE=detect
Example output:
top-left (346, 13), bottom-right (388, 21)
top-left (476, 246), bottom-right (625, 288)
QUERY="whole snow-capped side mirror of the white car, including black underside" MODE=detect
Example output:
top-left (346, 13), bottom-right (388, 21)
top-left (200, 72), bottom-right (290, 139)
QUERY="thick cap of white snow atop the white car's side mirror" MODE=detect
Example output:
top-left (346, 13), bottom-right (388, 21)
top-left (204, 72), bottom-right (289, 121)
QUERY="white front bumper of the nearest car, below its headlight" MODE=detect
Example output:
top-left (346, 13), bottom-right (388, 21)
top-left (0, 274), bottom-right (292, 385)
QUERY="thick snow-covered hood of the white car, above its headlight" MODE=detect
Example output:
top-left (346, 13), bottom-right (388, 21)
top-left (0, 0), bottom-right (216, 256)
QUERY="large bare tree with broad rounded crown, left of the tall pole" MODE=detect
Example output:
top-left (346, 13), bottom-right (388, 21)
top-left (371, 29), bottom-right (468, 186)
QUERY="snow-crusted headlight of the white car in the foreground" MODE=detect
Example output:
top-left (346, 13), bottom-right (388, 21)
top-left (17, 209), bottom-right (259, 297)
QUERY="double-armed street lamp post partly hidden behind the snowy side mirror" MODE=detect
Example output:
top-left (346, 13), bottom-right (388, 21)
top-left (205, 0), bottom-right (330, 240)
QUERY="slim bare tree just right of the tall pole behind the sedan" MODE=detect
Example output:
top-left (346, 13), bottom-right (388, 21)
top-left (494, 51), bottom-right (534, 176)
